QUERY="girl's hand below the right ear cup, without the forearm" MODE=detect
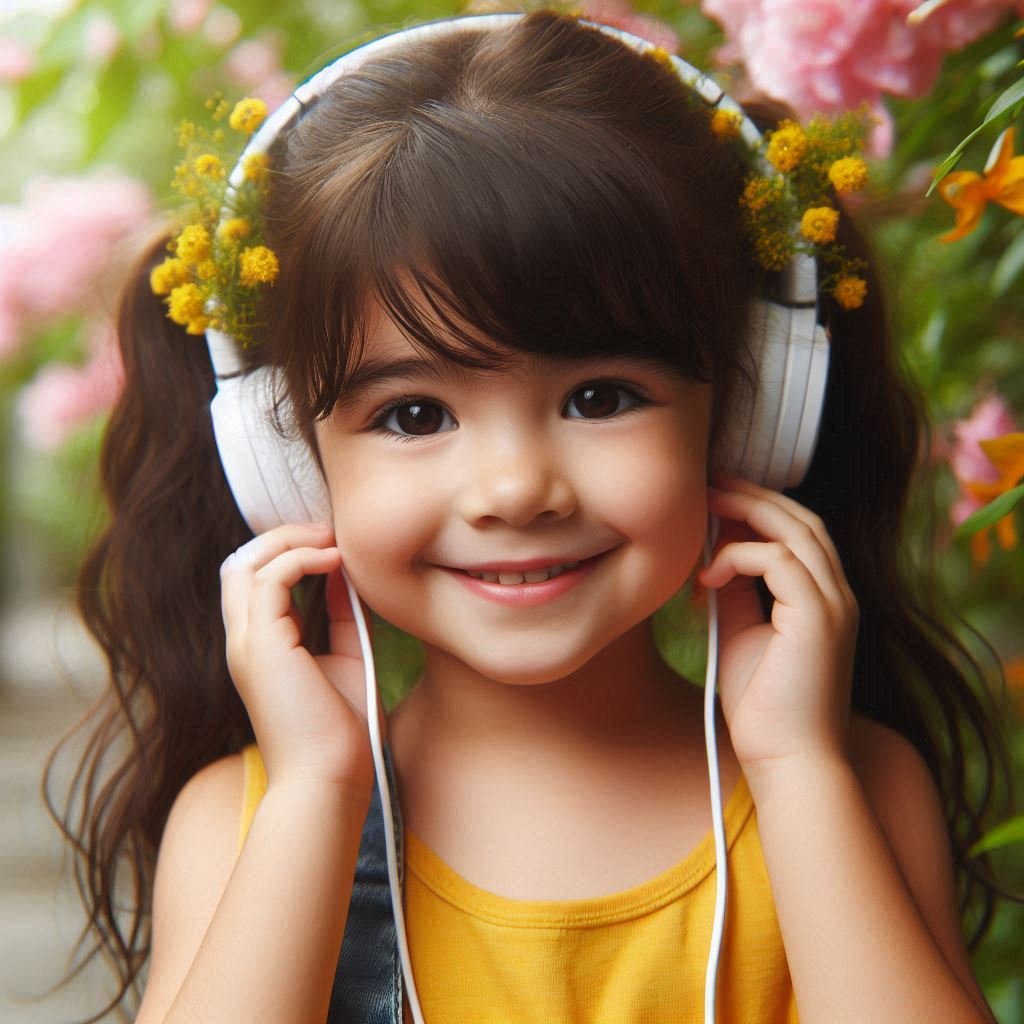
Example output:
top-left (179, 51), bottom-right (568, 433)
top-left (697, 478), bottom-right (858, 770)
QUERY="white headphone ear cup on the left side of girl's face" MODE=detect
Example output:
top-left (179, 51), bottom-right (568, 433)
top-left (210, 367), bottom-right (331, 535)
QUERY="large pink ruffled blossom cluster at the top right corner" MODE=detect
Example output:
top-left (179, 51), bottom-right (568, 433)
top-left (701, 0), bottom-right (1024, 156)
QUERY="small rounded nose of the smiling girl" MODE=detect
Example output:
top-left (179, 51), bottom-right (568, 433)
top-left (459, 435), bottom-right (577, 526)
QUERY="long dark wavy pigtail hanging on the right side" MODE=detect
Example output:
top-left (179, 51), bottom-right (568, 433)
top-left (792, 216), bottom-right (1012, 946)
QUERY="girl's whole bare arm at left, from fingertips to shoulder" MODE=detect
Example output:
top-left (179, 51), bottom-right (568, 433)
top-left (138, 524), bottom-right (373, 1024)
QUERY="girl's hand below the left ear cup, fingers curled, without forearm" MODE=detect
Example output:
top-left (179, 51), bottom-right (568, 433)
top-left (220, 524), bottom-right (373, 797)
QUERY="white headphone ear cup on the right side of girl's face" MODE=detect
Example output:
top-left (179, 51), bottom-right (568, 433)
top-left (711, 299), bottom-right (829, 490)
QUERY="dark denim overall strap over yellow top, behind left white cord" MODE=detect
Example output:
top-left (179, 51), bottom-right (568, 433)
top-left (328, 746), bottom-right (404, 1024)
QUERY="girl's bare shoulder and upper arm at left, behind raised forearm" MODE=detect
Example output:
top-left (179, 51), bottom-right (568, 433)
top-left (139, 754), bottom-right (245, 1020)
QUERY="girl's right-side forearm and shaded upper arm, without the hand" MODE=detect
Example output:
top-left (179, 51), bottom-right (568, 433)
top-left (748, 721), bottom-right (993, 1024)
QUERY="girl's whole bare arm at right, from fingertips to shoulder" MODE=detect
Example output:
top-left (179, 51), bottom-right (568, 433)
top-left (699, 480), bottom-right (992, 1024)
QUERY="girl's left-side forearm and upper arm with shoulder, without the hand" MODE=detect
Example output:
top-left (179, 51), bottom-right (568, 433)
top-left (137, 757), bottom-right (369, 1024)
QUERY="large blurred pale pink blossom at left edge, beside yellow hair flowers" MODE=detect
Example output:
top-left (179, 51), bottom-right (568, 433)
top-left (0, 174), bottom-right (152, 357)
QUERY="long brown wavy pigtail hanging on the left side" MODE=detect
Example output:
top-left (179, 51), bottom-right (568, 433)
top-left (46, 240), bottom-right (251, 1021)
